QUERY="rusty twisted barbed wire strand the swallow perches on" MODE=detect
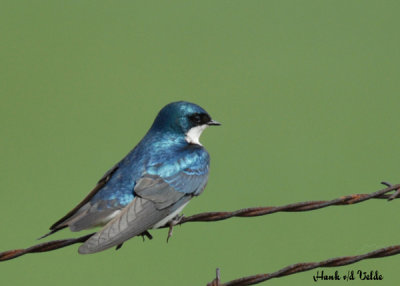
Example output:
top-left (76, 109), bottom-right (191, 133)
top-left (0, 182), bottom-right (400, 262)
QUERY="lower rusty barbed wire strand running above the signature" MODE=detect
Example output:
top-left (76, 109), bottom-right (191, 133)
top-left (207, 245), bottom-right (400, 286)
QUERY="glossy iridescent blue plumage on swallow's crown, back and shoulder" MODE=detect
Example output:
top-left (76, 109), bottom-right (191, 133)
top-left (91, 102), bottom-right (210, 206)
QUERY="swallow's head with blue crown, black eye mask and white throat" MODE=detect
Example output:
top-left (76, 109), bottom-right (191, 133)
top-left (150, 101), bottom-right (221, 145)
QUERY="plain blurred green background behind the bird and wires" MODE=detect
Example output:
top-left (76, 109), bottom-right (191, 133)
top-left (0, 0), bottom-right (400, 286)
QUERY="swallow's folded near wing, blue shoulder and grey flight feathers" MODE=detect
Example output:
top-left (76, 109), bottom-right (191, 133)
top-left (79, 150), bottom-right (208, 254)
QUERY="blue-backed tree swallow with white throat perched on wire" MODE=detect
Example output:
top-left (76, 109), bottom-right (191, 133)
top-left (43, 101), bottom-right (220, 254)
